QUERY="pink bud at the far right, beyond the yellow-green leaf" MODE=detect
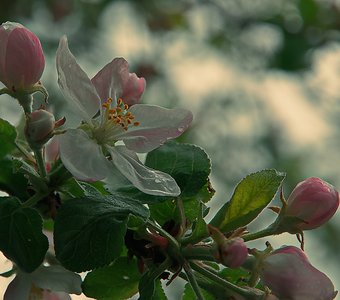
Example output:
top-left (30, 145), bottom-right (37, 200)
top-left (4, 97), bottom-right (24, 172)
top-left (285, 177), bottom-right (339, 230)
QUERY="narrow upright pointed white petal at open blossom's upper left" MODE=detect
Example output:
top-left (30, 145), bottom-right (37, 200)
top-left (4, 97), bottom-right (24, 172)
top-left (56, 36), bottom-right (100, 123)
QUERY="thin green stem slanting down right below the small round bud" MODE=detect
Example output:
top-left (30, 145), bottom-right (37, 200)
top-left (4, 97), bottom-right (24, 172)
top-left (190, 262), bottom-right (265, 300)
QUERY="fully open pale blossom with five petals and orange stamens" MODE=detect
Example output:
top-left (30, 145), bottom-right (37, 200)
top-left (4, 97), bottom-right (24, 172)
top-left (56, 37), bottom-right (192, 196)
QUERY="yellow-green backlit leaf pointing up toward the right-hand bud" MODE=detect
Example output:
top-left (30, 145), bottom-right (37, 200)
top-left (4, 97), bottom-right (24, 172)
top-left (211, 170), bottom-right (285, 232)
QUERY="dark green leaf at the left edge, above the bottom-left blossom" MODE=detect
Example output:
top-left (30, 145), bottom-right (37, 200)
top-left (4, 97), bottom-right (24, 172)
top-left (0, 197), bottom-right (48, 273)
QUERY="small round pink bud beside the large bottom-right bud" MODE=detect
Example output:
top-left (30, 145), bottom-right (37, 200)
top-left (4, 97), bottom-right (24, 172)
top-left (219, 238), bottom-right (248, 269)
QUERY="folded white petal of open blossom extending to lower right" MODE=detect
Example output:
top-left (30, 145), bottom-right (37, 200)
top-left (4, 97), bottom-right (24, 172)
top-left (108, 146), bottom-right (181, 196)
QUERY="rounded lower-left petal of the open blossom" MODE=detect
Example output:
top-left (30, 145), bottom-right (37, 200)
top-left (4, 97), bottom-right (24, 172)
top-left (59, 129), bottom-right (110, 181)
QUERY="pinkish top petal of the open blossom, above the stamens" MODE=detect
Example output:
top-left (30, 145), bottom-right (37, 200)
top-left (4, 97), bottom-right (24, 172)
top-left (91, 58), bottom-right (129, 101)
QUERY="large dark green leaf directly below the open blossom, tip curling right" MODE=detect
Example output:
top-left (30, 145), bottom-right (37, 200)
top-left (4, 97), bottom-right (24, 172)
top-left (54, 195), bottom-right (149, 272)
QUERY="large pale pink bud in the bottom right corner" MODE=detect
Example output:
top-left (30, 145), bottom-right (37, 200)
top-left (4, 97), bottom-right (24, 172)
top-left (260, 246), bottom-right (337, 300)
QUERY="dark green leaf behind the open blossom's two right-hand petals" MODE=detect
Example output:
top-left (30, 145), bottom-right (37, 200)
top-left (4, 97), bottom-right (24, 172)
top-left (145, 141), bottom-right (211, 197)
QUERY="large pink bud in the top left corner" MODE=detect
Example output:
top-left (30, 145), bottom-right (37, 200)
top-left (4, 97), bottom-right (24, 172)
top-left (0, 22), bottom-right (45, 91)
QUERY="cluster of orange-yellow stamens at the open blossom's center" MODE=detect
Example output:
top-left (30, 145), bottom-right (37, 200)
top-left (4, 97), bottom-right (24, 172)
top-left (102, 98), bottom-right (139, 130)
